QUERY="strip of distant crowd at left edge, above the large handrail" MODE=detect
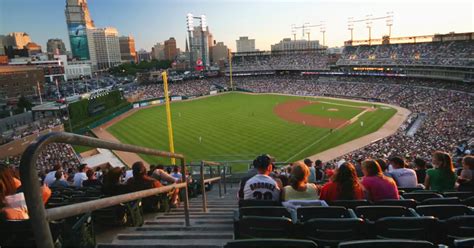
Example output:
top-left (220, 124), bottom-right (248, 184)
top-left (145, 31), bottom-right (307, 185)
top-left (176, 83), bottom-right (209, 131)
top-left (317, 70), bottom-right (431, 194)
top-left (0, 118), bottom-right (62, 145)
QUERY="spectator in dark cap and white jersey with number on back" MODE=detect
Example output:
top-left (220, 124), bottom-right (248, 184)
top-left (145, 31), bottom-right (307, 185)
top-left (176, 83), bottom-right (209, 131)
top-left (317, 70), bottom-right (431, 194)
top-left (243, 154), bottom-right (281, 201)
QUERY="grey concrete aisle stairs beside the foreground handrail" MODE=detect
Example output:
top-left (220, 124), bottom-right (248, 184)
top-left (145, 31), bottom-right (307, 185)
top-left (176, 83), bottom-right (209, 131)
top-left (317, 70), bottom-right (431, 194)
top-left (97, 184), bottom-right (238, 248)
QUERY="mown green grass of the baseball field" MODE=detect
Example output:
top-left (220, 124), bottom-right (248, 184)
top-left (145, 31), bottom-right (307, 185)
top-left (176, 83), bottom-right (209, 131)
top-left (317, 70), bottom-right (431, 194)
top-left (107, 93), bottom-right (396, 169)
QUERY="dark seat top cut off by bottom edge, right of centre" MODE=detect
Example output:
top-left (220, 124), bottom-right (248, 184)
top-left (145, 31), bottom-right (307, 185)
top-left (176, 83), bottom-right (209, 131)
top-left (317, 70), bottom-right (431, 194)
top-left (338, 239), bottom-right (437, 248)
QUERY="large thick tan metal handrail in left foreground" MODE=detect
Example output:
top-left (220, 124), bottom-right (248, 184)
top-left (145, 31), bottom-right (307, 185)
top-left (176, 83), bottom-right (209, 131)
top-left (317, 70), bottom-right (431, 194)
top-left (20, 132), bottom-right (190, 248)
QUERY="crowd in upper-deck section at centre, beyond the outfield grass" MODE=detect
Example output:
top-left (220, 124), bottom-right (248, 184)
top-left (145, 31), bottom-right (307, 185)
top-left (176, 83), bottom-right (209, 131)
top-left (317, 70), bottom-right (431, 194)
top-left (232, 51), bottom-right (329, 72)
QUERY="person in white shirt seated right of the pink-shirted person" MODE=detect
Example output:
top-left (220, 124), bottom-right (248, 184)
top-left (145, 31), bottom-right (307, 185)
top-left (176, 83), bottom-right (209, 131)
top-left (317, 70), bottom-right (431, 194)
top-left (389, 157), bottom-right (419, 188)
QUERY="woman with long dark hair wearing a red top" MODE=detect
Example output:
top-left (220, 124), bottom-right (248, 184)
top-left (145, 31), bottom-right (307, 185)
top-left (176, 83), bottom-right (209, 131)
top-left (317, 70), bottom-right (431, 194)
top-left (319, 162), bottom-right (365, 201)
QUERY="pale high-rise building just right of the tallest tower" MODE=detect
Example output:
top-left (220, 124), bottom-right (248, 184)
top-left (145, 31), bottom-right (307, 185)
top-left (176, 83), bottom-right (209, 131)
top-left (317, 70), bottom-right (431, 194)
top-left (87, 27), bottom-right (121, 70)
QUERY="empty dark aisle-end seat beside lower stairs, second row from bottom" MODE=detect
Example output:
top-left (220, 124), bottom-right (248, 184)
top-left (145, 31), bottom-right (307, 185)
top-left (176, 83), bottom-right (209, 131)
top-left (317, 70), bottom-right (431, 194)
top-left (234, 216), bottom-right (293, 239)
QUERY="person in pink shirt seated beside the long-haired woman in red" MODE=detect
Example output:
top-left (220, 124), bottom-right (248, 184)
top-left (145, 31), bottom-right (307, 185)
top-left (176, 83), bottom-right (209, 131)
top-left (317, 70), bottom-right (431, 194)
top-left (361, 159), bottom-right (400, 201)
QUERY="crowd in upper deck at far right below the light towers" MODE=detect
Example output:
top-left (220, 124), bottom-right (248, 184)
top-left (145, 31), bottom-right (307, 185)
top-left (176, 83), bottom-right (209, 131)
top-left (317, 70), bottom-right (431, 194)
top-left (337, 41), bottom-right (474, 66)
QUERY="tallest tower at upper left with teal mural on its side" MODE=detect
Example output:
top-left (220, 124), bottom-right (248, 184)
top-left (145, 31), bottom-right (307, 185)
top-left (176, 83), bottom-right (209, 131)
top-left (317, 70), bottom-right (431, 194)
top-left (65, 0), bottom-right (94, 60)
